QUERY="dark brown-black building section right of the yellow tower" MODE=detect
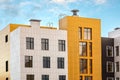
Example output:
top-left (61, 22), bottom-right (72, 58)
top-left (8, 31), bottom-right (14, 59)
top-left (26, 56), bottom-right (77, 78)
top-left (101, 37), bottom-right (115, 80)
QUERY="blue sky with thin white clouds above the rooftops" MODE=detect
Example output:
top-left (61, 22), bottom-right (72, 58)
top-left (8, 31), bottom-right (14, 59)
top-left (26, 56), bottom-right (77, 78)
top-left (0, 0), bottom-right (120, 36)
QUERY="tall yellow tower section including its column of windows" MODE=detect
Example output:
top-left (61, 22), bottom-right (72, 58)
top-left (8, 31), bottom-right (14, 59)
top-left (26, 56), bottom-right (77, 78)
top-left (59, 16), bottom-right (101, 80)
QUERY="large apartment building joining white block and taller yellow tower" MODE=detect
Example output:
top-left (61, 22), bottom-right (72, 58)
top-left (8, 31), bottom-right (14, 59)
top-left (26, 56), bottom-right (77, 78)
top-left (0, 10), bottom-right (102, 80)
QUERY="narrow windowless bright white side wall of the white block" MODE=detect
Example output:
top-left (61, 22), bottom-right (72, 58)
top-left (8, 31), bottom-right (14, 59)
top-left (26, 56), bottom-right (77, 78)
top-left (10, 29), bottom-right (21, 80)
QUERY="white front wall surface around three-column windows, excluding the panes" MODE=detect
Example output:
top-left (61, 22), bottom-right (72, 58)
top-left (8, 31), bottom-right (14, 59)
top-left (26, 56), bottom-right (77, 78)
top-left (12, 27), bottom-right (68, 80)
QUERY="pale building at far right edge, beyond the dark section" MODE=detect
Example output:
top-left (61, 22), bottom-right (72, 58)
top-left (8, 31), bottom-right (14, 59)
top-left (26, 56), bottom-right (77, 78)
top-left (108, 28), bottom-right (120, 80)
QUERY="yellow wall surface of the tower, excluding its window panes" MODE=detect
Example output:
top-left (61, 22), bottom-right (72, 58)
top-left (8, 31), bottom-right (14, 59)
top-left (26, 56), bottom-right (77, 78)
top-left (59, 16), bottom-right (101, 80)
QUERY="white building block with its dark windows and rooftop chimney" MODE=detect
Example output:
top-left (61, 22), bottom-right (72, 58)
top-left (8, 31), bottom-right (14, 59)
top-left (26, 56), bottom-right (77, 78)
top-left (0, 20), bottom-right (68, 80)
